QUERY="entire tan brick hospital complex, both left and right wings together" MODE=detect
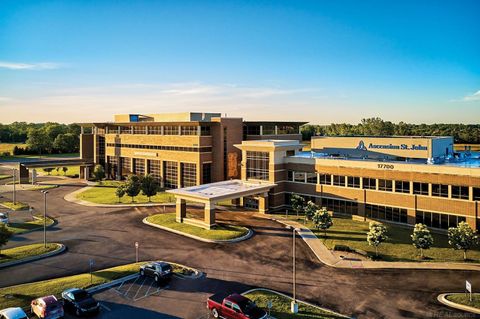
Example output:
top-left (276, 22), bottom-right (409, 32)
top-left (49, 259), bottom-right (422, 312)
top-left (81, 113), bottom-right (480, 229)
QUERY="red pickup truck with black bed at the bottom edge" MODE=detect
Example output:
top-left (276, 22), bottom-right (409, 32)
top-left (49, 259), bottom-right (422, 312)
top-left (207, 293), bottom-right (267, 319)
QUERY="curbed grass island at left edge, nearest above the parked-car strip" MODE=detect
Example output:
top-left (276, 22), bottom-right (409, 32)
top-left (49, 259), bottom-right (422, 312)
top-left (0, 243), bottom-right (66, 268)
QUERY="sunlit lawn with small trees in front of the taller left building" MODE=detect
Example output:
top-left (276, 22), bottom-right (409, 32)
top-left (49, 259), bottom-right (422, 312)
top-left (77, 188), bottom-right (175, 205)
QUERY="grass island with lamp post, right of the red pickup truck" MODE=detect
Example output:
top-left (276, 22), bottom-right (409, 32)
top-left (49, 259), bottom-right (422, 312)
top-left (242, 288), bottom-right (350, 319)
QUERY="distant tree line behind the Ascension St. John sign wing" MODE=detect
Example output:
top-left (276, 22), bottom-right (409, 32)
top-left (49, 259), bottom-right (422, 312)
top-left (301, 117), bottom-right (480, 144)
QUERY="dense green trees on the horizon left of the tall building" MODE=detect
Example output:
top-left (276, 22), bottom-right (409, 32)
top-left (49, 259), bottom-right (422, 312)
top-left (0, 122), bottom-right (80, 155)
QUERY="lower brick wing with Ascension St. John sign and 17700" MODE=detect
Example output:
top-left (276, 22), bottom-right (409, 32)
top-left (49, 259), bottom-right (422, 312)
top-left (238, 137), bottom-right (480, 229)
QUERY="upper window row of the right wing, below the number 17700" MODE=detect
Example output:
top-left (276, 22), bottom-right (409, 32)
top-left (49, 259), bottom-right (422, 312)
top-left (287, 170), bottom-right (480, 200)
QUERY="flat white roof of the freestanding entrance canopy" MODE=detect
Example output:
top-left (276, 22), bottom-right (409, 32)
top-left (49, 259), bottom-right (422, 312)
top-left (167, 179), bottom-right (276, 201)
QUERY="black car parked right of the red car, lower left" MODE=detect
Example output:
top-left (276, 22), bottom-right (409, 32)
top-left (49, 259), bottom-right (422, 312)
top-left (62, 288), bottom-right (100, 317)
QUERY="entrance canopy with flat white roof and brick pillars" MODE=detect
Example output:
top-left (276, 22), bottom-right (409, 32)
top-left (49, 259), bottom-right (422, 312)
top-left (167, 179), bottom-right (276, 229)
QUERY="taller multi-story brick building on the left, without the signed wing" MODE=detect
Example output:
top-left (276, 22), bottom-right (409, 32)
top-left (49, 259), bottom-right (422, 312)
top-left (80, 113), bottom-right (305, 188)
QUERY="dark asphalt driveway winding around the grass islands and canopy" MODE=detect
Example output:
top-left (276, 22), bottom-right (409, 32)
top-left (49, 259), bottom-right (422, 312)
top-left (0, 168), bottom-right (480, 318)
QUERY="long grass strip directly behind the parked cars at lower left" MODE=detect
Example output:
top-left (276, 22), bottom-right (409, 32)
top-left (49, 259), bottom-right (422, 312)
top-left (0, 263), bottom-right (144, 309)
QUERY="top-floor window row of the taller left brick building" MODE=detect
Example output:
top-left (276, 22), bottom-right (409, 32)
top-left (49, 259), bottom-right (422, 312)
top-left (104, 125), bottom-right (212, 136)
